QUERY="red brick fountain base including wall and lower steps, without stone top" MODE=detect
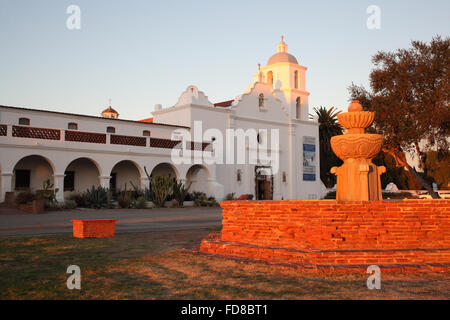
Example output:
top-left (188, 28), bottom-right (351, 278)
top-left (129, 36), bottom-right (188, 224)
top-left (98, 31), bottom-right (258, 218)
top-left (200, 200), bottom-right (450, 271)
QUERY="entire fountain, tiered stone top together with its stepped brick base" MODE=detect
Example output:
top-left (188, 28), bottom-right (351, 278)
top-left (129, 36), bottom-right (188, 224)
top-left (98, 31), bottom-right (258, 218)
top-left (200, 101), bottom-right (450, 274)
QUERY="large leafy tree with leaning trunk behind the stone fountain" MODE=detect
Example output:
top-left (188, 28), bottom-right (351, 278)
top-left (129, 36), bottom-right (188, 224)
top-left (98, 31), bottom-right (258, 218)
top-left (349, 36), bottom-right (450, 198)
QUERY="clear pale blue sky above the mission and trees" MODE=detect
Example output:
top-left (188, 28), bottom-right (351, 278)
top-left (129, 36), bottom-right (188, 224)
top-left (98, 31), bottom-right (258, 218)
top-left (0, 0), bottom-right (450, 120)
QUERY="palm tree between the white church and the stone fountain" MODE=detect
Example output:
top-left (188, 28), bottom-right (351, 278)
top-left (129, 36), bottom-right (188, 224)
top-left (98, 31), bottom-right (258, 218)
top-left (309, 106), bottom-right (343, 188)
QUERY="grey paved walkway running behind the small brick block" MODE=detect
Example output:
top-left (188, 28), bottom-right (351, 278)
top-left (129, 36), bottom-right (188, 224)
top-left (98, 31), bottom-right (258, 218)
top-left (0, 207), bottom-right (222, 237)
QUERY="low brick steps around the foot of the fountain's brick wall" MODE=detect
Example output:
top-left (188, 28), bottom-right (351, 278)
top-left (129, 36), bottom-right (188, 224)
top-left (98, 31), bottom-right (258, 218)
top-left (200, 233), bottom-right (450, 272)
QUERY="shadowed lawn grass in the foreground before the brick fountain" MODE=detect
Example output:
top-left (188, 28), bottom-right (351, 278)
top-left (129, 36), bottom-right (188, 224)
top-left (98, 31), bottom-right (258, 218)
top-left (0, 229), bottom-right (450, 299)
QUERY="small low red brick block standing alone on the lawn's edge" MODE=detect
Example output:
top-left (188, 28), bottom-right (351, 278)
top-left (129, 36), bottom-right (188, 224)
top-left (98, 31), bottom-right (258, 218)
top-left (72, 219), bottom-right (117, 238)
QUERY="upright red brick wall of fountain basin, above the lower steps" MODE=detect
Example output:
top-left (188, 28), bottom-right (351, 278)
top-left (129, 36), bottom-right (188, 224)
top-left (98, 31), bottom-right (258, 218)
top-left (221, 199), bottom-right (450, 251)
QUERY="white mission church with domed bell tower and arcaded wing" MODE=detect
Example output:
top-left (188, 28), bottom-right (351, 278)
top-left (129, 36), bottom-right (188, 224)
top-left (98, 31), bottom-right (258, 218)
top-left (0, 39), bottom-right (325, 202)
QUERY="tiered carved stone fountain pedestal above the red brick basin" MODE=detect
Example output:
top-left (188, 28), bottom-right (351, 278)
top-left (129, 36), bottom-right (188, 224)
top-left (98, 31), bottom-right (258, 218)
top-left (331, 101), bottom-right (386, 201)
